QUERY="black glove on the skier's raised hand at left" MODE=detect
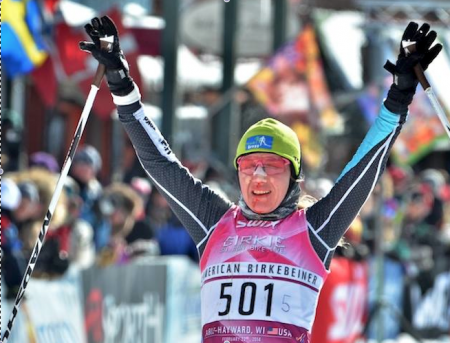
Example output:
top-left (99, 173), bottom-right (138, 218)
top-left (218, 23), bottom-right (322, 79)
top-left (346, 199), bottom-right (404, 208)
top-left (79, 16), bottom-right (134, 96)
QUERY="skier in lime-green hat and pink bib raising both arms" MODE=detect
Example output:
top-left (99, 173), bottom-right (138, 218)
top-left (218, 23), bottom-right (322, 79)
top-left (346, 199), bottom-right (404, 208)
top-left (80, 17), bottom-right (442, 343)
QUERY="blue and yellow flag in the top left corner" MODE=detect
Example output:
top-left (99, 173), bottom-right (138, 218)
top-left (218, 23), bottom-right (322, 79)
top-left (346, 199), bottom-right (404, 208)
top-left (1, 0), bottom-right (47, 77)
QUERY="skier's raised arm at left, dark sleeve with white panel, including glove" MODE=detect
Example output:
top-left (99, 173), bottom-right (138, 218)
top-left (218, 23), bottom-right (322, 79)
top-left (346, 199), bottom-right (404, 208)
top-left (80, 16), bottom-right (232, 253)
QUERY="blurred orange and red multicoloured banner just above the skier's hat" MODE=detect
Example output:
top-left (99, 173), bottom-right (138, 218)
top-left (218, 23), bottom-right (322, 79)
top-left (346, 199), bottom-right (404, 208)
top-left (247, 25), bottom-right (343, 169)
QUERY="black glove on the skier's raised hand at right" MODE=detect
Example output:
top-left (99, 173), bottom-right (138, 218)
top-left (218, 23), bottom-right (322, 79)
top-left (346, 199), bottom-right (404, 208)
top-left (384, 22), bottom-right (442, 114)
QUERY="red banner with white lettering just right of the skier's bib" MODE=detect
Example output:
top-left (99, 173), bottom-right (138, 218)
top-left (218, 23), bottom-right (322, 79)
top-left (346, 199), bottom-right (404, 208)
top-left (311, 256), bottom-right (368, 343)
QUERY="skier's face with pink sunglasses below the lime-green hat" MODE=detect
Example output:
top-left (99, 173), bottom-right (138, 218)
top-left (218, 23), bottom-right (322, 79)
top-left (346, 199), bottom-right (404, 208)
top-left (238, 153), bottom-right (291, 214)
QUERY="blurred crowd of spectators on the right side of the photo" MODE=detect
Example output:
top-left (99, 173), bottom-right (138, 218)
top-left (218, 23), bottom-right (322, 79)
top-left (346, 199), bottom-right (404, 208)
top-left (361, 166), bottom-right (450, 284)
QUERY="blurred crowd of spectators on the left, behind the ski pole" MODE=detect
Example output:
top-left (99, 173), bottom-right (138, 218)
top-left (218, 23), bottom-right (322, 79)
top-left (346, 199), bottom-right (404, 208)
top-left (1, 145), bottom-right (229, 298)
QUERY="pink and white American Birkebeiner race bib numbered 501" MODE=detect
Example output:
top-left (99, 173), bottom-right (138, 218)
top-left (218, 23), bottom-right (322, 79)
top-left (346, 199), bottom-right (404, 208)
top-left (200, 207), bottom-right (328, 343)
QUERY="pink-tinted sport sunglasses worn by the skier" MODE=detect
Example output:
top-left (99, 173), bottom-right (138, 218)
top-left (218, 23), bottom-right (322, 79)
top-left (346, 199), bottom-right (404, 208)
top-left (237, 155), bottom-right (290, 175)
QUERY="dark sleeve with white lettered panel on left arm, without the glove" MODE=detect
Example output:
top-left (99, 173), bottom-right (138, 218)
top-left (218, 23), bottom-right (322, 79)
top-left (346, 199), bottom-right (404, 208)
top-left (117, 102), bottom-right (232, 256)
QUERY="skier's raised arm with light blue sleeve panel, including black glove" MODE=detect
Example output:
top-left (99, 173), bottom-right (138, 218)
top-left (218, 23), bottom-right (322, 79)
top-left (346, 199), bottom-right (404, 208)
top-left (306, 22), bottom-right (442, 268)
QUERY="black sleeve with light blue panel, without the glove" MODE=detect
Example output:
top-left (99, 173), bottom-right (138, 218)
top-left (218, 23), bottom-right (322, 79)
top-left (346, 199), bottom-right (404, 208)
top-left (306, 105), bottom-right (406, 268)
